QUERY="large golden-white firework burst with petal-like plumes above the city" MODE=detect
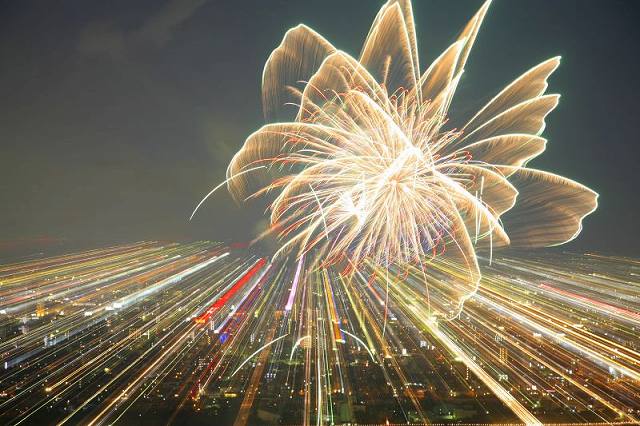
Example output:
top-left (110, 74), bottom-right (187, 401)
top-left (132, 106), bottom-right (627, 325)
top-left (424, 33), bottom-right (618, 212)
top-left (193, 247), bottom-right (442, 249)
top-left (222, 0), bottom-right (598, 317)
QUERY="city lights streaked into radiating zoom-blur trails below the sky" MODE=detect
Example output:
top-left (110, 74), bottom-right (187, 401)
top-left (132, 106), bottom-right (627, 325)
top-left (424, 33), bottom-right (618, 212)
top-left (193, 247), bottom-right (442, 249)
top-left (0, 242), bottom-right (640, 425)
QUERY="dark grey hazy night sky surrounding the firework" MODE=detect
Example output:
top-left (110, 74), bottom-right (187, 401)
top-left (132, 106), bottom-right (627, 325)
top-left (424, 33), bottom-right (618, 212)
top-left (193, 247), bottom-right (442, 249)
top-left (0, 0), bottom-right (640, 256)
